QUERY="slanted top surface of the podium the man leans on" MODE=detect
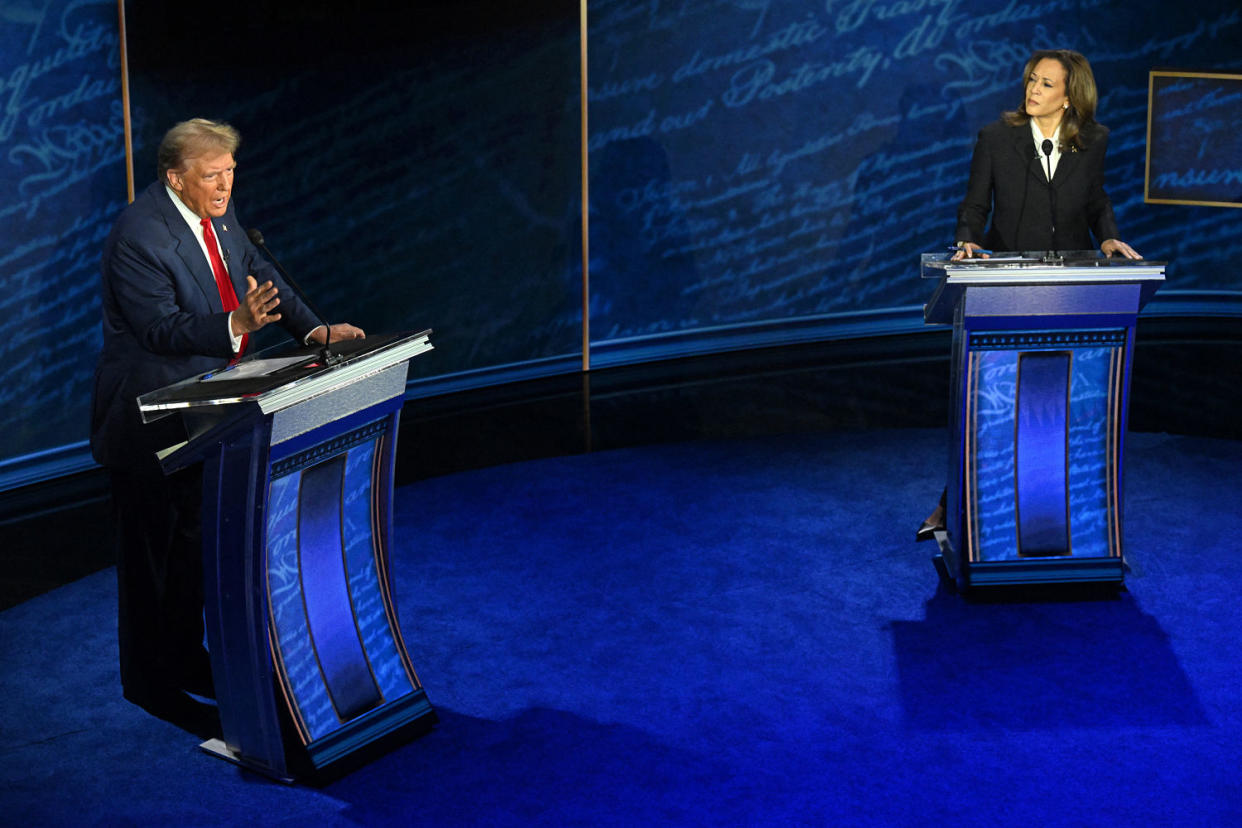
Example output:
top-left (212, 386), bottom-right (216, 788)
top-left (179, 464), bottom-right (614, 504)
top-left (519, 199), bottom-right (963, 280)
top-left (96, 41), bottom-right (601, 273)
top-left (138, 329), bottom-right (432, 422)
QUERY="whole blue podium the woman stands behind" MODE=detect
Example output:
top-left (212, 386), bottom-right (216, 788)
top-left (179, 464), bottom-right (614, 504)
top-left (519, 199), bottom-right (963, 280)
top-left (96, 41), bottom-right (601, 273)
top-left (922, 251), bottom-right (1165, 590)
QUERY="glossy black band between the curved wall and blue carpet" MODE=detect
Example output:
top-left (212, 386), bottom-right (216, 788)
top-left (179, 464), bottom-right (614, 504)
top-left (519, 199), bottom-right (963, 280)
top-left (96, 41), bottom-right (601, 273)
top-left (0, 318), bottom-right (1242, 610)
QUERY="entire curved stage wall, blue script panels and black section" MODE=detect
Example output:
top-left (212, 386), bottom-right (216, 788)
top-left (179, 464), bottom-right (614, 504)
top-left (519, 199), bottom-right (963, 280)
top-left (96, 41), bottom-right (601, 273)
top-left (0, 0), bottom-right (1242, 488)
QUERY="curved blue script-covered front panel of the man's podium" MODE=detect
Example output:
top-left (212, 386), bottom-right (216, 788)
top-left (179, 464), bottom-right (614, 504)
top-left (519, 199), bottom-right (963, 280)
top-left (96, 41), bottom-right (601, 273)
top-left (267, 416), bottom-right (421, 754)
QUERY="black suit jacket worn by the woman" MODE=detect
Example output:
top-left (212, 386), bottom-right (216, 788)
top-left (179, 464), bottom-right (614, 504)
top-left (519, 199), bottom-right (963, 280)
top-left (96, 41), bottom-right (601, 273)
top-left (956, 120), bottom-right (1119, 251)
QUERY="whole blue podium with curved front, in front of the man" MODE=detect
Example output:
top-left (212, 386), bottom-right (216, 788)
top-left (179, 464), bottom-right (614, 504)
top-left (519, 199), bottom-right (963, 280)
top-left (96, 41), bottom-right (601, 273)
top-left (138, 331), bottom-right (436, 781)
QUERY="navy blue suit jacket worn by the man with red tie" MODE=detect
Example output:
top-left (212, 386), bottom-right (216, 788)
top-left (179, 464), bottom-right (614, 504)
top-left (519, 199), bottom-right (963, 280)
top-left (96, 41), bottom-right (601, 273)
top-left (91, 181), bottom-right (319, 473)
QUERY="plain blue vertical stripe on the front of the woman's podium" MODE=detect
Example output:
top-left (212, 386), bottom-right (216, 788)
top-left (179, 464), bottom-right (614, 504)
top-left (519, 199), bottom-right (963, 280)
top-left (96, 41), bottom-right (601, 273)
top-left (1015, 353), bottom-right (1069, 557)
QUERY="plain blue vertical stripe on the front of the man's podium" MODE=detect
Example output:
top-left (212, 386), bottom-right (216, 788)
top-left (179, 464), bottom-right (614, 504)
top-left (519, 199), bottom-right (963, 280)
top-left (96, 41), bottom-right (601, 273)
top-left (298, 456), bottom-right (380, 721)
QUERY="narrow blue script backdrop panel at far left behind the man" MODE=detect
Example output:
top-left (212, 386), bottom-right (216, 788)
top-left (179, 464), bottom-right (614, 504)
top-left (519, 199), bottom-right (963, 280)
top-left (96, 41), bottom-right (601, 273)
top-left (0, 0), bottom-right (125, 488)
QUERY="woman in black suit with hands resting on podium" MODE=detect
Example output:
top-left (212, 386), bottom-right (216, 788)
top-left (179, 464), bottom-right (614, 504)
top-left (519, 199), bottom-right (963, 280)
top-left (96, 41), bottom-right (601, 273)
top-left (954, 48), bottom-right (1140, 259)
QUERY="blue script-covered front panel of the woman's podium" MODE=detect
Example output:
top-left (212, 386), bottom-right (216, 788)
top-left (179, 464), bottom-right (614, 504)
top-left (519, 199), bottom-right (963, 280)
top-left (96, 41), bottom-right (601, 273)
top-left (964, 330), bottom-right (1126, 562)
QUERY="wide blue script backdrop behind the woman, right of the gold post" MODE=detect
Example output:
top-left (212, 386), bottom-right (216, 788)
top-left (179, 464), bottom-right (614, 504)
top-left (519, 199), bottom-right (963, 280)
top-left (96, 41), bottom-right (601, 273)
top-left (589, 0), bottom-right (1242, 360)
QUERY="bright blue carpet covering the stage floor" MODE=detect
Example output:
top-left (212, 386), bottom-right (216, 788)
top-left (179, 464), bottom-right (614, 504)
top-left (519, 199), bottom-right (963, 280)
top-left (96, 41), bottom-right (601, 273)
top-left (0, 431), bottom-right (1242, 826)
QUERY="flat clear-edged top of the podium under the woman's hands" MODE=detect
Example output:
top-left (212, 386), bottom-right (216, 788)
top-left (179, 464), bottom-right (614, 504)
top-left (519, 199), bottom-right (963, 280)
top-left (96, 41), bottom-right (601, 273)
top-left (919, 251), bottom-right (1167, 284)
